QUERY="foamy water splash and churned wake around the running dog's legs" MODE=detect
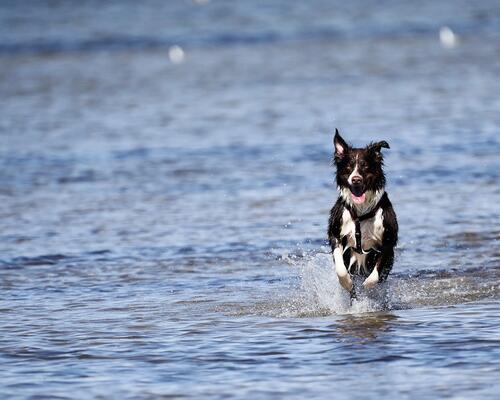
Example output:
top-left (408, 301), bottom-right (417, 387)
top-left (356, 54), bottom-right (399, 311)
top-left (238, 253), bottom-right (500, 318)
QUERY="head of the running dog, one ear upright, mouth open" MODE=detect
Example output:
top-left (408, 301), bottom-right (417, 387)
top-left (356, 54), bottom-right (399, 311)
top-left (333, 129), bottom-right (389, 205)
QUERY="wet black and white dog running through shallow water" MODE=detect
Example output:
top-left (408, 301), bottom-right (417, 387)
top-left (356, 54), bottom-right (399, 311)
top-left (328, 129), bottom-right (398, 298)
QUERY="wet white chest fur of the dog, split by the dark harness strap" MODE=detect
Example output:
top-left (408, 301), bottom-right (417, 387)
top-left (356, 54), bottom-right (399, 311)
top-left (340, 208), bottom-right (384, 269)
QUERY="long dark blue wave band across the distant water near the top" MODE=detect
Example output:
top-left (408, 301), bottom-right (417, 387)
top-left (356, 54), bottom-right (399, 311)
top-left (0, 23), bottom-right (500, 56)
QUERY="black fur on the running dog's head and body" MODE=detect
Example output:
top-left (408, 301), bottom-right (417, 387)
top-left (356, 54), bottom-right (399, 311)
top-left (328, 130), bottom-right (398, 290)
